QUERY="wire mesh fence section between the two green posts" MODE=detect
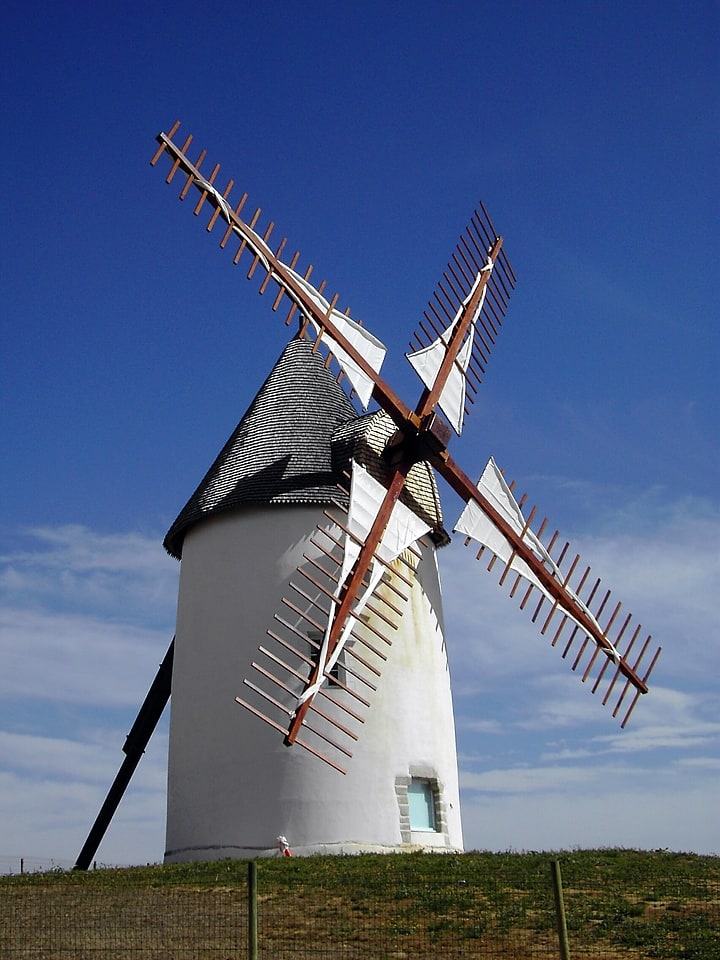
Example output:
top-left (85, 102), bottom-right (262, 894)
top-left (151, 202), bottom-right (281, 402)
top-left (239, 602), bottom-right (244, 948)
top-left (255, 860), bottom-right (558, 960)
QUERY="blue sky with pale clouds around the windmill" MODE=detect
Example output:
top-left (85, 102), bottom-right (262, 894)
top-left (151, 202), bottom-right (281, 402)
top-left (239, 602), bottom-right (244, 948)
top-left (0, 0), bottom-right (720, 869)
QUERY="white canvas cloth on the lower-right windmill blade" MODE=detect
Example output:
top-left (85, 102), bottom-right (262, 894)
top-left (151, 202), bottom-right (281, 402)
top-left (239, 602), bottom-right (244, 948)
top-left (454, 457), bottom-right (620, 663)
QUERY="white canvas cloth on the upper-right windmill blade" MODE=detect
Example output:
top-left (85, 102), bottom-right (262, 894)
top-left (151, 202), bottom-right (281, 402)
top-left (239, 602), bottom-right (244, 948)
top-left (406, 260), bottom-right (493, 436)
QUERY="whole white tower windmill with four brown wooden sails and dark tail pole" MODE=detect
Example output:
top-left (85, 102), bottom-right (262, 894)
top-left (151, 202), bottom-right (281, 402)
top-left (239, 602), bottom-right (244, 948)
top-left (77, 123), bottom-right (660, 867)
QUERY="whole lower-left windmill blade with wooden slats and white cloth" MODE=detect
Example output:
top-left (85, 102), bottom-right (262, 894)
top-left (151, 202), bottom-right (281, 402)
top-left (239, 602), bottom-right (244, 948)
top-left (236, 463), bottom-right (430, 773)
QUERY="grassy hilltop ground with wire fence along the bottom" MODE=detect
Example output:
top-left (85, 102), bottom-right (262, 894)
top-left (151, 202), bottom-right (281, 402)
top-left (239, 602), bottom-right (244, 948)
top-left (0, 852), bottom-right (720, 960)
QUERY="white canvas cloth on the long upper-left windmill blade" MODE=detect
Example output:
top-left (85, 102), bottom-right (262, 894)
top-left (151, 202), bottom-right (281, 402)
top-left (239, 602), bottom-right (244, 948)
top-left (195, 177), bottom-right (387, 409)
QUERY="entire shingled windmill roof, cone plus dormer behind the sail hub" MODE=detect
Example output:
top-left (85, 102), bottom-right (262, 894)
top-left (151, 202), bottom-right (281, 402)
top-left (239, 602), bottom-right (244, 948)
top-left (163, 337), bottom-right (448, 560)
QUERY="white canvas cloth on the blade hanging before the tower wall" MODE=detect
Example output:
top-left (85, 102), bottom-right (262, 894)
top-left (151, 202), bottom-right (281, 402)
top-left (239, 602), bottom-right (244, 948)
top-left (298, 461), bottom-right (430, 705)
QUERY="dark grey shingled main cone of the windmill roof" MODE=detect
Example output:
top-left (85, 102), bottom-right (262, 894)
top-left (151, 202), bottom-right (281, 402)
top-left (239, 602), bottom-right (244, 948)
top-left (164, 338), bottom-right (358, 559)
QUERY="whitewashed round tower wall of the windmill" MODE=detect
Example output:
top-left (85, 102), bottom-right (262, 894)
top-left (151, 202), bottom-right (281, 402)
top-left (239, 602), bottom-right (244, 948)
top-left (166, 506), bottom-right (462, 862)
